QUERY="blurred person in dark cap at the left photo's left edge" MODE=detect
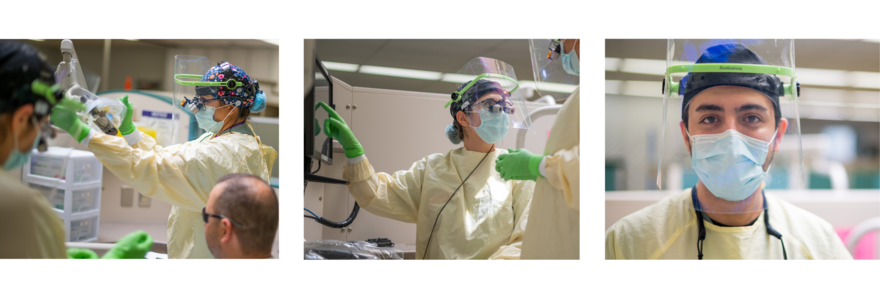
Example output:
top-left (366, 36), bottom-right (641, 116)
top-left (0, 41), bottom-right (67, 258)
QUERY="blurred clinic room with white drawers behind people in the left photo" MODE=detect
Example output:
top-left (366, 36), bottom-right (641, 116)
top-left (6, 39), bottom-right (281, 257)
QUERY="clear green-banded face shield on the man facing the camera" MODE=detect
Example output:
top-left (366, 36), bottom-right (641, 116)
top-left (657, 40), bottom-right (805, 213)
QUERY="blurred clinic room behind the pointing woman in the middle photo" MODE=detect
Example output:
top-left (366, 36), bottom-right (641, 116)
top-left (304, 39), bottom-right (577, 258)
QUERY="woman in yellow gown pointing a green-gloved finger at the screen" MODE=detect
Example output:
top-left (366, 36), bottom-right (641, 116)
top-left (318, 79), bottom-right (535, 259)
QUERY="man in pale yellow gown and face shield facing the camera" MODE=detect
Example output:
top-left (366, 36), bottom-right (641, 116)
top-left (605, 40), bottom-right (852, 260)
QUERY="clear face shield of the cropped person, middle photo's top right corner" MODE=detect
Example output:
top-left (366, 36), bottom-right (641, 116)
top-left (529, 39), bottom-right (580, 101)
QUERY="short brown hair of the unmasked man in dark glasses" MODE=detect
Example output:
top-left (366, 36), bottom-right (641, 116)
top-left (214, 174), bottom-right (278, 254)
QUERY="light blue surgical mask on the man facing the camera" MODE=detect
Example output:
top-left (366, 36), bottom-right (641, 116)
top-left (688, 129), bottom-right (776, 201)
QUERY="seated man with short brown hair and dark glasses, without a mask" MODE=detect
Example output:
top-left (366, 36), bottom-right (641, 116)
top-left (202, 174), bottom-right (278, 258)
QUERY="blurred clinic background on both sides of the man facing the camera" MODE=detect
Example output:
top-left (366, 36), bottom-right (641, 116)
top-left (605, 39), bottom-right (880, 259)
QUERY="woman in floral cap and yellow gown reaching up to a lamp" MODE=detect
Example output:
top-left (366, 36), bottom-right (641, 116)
top-left (52, 62), bottom-right (278, 258)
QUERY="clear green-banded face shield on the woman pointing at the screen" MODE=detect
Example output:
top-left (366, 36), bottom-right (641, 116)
top-left (445, 57), bottom-right (534, 143)
